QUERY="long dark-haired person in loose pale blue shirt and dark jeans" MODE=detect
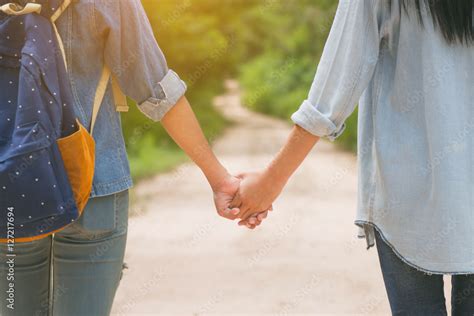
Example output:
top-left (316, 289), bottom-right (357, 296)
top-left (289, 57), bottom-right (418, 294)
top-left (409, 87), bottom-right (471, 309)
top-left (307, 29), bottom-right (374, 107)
top-left (232, 0), bottom-right (474, 315)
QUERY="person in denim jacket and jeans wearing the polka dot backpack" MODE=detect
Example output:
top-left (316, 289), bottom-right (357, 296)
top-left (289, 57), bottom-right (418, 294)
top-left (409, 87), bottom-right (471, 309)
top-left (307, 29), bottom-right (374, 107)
top-left (0, 0), bottom-right (262, 316)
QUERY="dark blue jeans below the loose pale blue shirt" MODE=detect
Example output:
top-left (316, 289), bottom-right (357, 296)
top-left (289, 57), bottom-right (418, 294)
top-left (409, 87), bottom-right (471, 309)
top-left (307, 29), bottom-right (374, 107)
top-left (375, 230), bottom-right (474, 316)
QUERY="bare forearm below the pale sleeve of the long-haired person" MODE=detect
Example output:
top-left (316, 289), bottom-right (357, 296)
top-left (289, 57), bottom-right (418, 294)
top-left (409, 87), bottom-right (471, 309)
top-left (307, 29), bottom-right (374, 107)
top-left (265, 125), bottom-right (320, 186)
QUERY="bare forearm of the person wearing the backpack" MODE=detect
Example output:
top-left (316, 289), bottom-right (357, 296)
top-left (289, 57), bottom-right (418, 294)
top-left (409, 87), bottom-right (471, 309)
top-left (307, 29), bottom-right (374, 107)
top-left (161, 97), bottom-right (227, 188)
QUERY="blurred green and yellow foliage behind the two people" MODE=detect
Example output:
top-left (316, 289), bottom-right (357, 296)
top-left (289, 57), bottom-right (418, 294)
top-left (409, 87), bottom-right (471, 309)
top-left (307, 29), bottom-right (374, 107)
top-left (123, 0), bottom-right (356, 178)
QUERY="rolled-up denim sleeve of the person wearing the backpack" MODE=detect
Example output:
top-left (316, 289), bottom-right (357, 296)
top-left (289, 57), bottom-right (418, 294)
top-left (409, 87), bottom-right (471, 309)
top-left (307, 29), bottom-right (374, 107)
top-left (94, 0), bottom-right (187, 121)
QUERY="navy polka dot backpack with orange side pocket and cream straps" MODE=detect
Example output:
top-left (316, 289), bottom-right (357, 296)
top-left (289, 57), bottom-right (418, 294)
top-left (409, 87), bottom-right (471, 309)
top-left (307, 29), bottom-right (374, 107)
top-left (0, 0), bottom-right (126, 244)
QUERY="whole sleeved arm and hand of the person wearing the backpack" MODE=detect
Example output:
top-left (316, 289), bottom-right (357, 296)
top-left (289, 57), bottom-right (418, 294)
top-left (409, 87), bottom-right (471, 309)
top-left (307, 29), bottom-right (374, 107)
top-left (93, 0), bottom-right (246, 219)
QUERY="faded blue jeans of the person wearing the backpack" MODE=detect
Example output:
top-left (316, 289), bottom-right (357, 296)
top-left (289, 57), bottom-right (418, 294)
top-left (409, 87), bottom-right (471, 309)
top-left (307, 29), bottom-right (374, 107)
top-left (0, 191), bottom-right (128, 316)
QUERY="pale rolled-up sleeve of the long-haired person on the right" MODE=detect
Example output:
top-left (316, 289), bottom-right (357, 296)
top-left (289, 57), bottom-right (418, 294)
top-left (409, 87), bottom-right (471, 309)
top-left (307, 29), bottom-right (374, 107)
top-left (291, 0), bottom-right (383, 141)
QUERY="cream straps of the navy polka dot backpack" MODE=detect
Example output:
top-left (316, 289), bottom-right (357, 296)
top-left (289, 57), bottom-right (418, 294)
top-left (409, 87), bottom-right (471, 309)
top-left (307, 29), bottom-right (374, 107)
top-left (51, 0), bottom-right (129, 134)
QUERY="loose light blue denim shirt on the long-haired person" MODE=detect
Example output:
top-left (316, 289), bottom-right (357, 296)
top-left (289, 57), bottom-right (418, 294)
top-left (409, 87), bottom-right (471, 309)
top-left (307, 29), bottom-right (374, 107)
top-left (292, 0), bottom-right (474, 274)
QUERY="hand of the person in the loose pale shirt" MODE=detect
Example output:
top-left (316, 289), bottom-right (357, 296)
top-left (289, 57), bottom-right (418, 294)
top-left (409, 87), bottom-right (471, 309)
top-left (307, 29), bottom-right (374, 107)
top-left (230, 173), bottom-right (283, 228)
